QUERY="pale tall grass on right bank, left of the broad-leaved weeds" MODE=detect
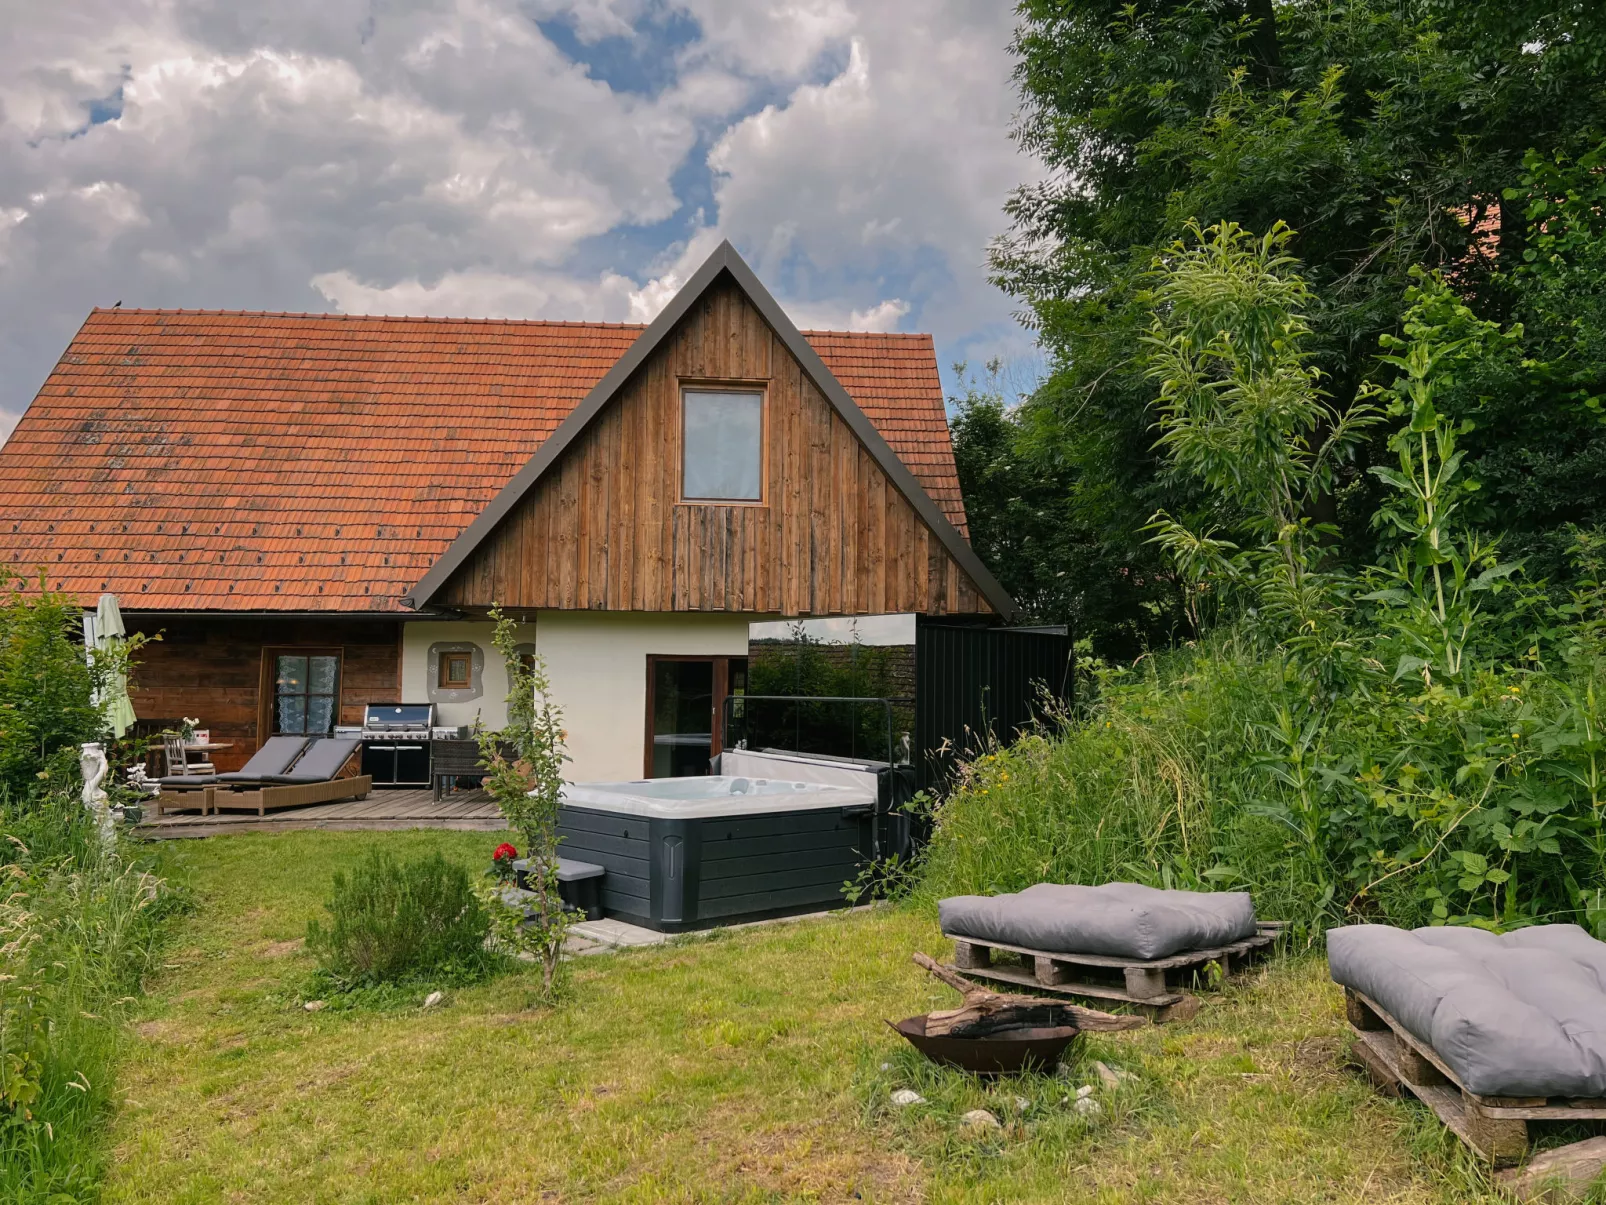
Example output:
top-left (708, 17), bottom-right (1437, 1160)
top-left (922, 633), bottom-right (1320, 917)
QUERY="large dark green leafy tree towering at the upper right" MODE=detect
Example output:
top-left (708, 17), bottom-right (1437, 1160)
top-left (993, 0), bottom-right (1606, 652)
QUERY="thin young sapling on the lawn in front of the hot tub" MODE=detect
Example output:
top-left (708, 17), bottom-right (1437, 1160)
top-left (479, 607), bottom-right (569, 996)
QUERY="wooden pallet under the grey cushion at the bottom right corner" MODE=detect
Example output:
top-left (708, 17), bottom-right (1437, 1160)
top-left (1344, 988), bottom-right (1606, 1187)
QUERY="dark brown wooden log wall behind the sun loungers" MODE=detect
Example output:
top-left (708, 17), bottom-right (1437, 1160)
top-left (124, 614), bottom-right (402, 770)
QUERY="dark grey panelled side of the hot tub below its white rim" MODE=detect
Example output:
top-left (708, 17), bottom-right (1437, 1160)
top-left (557, 805), bottom-right (870, 932)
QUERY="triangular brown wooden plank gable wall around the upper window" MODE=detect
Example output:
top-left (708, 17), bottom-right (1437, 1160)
top-left (437, 283), bottom-right (991, 615)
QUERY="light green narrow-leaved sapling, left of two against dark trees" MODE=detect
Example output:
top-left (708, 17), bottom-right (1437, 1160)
top-left (1142, 222), bottom-right (1380, 652)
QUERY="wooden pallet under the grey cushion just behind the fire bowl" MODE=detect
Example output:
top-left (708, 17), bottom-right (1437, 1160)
top-left (944, 921), bottom-right (1286, 1023)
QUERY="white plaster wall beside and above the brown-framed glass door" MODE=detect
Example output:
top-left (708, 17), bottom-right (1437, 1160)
top-left (529, 611), bottom-right (748, 782)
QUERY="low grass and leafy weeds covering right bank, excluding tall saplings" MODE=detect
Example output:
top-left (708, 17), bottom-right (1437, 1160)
top-left (919, 607), bottom-right (1606, 938)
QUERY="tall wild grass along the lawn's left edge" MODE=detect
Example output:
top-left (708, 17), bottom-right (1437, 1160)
top-left (0, 797), bottom-right (180, 1205)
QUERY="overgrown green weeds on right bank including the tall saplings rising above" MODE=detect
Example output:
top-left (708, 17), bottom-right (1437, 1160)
top-left (923, 233), bottom-right (1606, 940)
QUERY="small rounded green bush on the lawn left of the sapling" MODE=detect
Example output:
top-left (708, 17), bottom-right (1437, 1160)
top-left (307, 850), bottom-right (491, 988)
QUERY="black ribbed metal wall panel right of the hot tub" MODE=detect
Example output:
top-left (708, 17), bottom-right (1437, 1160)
top-left (914, 622), bottom-right (1074, 789)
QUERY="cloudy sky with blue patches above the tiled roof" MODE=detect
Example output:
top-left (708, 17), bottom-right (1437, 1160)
top-left (0, 0), bottom-right (1034, 435)
